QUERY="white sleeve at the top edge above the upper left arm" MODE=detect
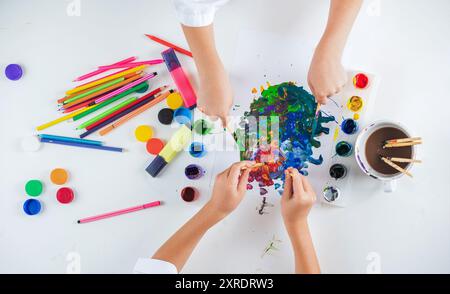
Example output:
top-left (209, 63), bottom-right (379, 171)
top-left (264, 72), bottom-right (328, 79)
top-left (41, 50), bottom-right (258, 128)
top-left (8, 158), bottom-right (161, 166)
top-left (174, 0), bottom-right (228, 27)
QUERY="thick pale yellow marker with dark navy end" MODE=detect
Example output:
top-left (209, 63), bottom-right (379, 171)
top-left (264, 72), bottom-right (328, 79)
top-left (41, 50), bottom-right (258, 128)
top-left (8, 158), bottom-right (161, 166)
top-left (145, 125), bottom-right (192, 178)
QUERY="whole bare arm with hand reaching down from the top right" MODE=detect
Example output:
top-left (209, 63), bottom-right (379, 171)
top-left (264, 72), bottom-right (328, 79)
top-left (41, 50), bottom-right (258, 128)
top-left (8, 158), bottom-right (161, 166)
top-left (308, 0), bottom-right (362, 104)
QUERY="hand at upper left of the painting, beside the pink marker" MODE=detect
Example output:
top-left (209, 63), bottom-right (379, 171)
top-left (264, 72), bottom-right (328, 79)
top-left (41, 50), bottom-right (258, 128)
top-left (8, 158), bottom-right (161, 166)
top-left (197, 66), bottom-right (233, 127)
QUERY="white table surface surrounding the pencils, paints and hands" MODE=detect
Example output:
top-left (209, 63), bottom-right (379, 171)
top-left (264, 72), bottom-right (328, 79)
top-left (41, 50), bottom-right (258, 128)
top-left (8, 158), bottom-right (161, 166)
top-left (0, 0), bottom-right (450, 273)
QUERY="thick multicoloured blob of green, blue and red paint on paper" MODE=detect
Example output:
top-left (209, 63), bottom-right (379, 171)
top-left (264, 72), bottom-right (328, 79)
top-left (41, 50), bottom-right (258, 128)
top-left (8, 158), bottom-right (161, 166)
top-left (235, 82), bottom-right (335, 188)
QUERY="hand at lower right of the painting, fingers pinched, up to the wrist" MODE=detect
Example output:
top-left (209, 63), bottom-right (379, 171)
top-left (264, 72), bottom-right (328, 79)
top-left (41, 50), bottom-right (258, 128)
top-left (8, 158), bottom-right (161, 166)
top-left (281, 168), bottom-right (316, 231)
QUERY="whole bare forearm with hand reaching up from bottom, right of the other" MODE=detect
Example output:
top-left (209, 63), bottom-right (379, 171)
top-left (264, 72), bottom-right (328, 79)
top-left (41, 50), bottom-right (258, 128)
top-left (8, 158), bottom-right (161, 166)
top-left (281, 169), bottom-right (320, 274)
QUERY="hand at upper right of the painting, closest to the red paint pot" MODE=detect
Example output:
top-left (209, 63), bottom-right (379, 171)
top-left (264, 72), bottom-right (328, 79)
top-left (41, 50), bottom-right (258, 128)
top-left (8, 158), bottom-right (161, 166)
top-left (308, 47), bottom-right (347, 104)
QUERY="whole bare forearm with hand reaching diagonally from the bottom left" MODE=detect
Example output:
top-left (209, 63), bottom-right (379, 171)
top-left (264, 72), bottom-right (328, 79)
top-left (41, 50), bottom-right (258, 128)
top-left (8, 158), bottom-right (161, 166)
top-left (152, 161), bottom-right (252, 271)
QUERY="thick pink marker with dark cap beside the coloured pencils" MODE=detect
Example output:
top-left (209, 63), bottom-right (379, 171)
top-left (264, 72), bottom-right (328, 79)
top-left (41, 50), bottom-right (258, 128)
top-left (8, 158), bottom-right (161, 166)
top-left (162, 48), bottom-right (197, 109)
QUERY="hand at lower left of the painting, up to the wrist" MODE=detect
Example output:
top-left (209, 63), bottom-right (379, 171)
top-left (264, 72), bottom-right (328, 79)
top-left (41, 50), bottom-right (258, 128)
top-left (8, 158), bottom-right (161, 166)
top-left (206, 161), bottom-right (254, 219)
